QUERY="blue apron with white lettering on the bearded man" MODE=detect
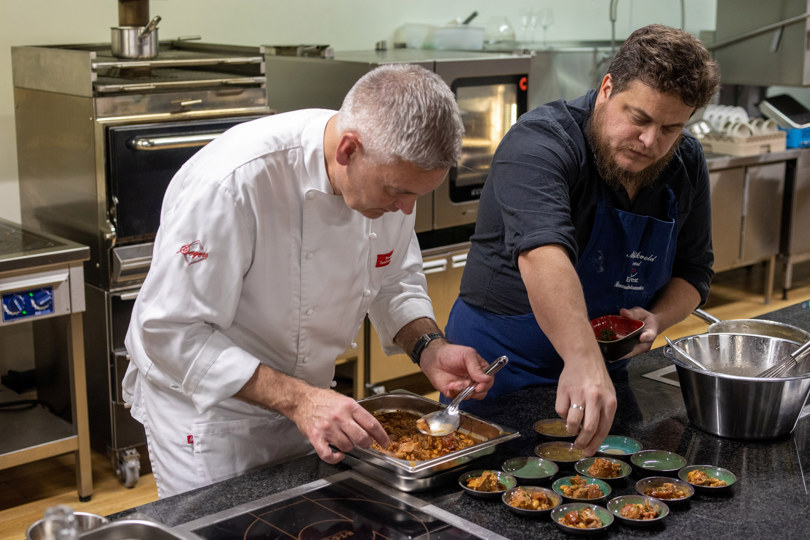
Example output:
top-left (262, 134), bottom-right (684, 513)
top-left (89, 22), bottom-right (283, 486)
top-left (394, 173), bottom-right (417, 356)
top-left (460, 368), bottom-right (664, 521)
top-left (442, 188), bottom-right (678, 404)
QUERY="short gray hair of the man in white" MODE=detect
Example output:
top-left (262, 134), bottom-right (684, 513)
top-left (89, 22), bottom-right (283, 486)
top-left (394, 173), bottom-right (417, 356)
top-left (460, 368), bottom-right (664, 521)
top-left (338, 64), bottom-right (464, 170)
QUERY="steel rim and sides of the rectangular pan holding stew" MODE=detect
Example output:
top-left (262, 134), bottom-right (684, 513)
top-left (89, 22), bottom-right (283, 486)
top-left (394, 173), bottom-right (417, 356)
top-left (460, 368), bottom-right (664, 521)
top-left (345, 391), bottom-right (520, 491)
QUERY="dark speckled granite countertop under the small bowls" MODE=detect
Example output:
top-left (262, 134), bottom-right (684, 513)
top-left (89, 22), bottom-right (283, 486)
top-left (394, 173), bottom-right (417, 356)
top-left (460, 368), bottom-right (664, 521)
top-left (110, 302), bottom-right (810, 538)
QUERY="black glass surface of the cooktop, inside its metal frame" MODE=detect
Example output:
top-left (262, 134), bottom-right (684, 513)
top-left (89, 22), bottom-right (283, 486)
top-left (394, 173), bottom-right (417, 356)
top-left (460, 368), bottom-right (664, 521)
top-left (193, 478), bottom-right (478, 540)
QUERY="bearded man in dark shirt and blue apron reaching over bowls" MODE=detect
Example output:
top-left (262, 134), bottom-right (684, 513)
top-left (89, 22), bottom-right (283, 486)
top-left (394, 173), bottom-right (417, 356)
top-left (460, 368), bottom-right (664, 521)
top-left (446, 25), bottom-right (719, 455)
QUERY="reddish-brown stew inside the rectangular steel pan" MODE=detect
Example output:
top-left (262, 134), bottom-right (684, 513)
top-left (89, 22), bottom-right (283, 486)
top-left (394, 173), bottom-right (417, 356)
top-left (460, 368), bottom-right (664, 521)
top-left (371, 411), bottom-right (481, 461)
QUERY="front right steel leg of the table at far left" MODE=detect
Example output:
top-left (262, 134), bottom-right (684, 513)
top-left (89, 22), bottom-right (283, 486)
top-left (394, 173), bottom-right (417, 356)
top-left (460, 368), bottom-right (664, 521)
top-left (68, 312), bottom-right (93, 501)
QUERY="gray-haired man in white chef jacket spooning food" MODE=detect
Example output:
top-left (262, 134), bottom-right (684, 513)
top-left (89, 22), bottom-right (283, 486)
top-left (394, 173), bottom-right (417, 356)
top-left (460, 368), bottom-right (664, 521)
top-left (123, 65), bottom-right (492, 498)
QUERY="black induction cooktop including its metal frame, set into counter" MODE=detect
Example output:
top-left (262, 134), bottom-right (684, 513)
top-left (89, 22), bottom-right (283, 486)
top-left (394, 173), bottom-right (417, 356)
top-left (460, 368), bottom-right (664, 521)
top-left (178, 471), bottom-right (503, 540)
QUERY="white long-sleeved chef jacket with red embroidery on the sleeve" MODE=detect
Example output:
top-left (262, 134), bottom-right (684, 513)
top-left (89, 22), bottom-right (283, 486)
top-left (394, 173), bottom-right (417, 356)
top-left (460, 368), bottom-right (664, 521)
top-left (123, 110), bottom-right (433, 494)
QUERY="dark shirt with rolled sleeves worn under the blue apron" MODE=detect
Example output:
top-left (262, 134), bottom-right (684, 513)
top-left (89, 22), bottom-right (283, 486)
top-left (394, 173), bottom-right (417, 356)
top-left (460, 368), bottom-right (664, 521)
top-left (460, 90), bottom-right (714, 315)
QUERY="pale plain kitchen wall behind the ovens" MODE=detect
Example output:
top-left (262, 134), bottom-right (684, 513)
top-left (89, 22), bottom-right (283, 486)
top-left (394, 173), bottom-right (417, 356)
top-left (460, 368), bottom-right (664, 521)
top-left (0, 0), bottom-right (716, 225)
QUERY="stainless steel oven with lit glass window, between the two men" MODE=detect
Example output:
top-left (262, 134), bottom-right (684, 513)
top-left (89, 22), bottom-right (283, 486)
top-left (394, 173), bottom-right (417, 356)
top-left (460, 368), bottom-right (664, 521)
top-left (265, 46), bottom-right (531, 247)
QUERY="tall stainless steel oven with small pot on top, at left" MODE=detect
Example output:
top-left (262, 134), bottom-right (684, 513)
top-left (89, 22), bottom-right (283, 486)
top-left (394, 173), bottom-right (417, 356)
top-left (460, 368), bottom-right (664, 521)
top-left (12, 41), bottom-right (270, 487)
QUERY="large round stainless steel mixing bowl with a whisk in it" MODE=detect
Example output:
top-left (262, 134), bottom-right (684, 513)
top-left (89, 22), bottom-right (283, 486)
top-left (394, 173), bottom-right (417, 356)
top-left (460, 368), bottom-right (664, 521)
top-left (664, 334), bottom-right (810, 440)
